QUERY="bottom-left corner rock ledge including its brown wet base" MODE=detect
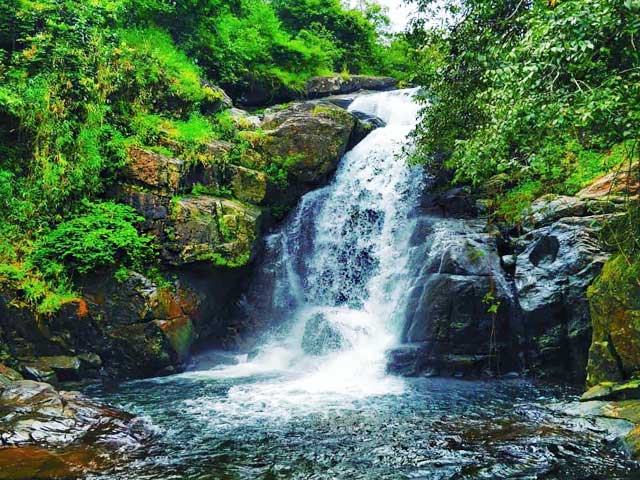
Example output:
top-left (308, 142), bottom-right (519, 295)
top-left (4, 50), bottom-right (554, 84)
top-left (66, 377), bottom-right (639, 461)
top-left (0, 365), bottom-right (152, 480)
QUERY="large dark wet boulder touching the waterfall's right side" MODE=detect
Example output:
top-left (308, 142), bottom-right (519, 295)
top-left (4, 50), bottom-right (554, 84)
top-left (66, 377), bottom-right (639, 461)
top-left (389, 217), bottom-right (516, 375)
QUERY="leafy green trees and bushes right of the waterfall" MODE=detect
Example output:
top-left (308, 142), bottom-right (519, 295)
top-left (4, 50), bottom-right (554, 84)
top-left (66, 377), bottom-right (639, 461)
top-left (409, 0), bottom-right (640, 281)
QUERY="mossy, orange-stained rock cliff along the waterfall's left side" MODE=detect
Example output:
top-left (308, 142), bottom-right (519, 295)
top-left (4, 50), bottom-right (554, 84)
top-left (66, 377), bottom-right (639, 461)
top-left (0, 82), bottom-right (389, 384)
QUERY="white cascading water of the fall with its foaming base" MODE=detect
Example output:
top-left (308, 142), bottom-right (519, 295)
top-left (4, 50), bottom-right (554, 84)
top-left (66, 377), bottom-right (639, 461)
top-left (178, 90), bottom-right (421, 420)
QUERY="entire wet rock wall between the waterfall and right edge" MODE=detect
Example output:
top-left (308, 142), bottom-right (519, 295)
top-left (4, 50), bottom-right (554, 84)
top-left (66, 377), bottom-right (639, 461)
top-left (389, 161), bottom-right (640, 385)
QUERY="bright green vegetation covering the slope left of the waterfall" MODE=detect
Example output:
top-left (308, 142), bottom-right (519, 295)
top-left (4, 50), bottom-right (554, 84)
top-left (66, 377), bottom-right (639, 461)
top-left (0, 0), bottom-right (402, 312)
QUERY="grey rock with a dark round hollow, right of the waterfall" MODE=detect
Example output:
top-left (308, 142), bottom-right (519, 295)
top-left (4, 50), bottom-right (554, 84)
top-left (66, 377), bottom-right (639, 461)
top-left (515, 216), bottom-right (608, 381)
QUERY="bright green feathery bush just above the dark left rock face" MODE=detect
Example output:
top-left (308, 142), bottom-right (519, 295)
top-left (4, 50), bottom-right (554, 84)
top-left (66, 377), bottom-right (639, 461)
top-left (32, 202), bottom-right (153, 276)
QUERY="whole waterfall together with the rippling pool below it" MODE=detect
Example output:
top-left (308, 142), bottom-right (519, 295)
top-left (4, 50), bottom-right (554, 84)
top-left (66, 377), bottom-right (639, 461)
top-left (90, 90), bottom-right (634, 480)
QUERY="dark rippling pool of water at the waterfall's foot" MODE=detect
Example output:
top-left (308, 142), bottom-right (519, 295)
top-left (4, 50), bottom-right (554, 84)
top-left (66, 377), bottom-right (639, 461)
top-left (82, 369), bottom-right (638, 480)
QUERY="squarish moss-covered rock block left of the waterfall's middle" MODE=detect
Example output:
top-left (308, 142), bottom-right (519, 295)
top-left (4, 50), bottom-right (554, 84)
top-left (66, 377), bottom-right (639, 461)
top-left (161, 196), bottom-right (262, 267)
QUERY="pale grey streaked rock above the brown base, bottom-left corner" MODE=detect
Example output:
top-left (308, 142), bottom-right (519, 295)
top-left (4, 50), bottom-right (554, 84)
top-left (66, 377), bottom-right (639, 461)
top-left (0, 380), bottom-right (150, 448)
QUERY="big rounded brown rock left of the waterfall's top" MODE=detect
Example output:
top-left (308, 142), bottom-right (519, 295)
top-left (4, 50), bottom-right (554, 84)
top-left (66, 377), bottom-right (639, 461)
top-left (261, 102), bottom-right (355, 187)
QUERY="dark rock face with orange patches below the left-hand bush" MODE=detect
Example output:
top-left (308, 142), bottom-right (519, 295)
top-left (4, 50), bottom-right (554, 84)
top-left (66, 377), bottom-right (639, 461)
top-left (0, 272), bottom-right (197, 384)
